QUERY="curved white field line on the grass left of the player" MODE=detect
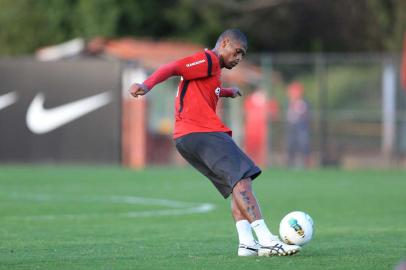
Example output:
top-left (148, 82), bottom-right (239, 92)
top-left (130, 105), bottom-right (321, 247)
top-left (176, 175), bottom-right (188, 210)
top-left (2, 193), bottom-right (215, 220)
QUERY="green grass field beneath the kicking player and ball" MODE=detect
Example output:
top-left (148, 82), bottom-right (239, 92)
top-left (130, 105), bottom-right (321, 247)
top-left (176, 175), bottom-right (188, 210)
top-left (0, 166), bottom-right (406, 270)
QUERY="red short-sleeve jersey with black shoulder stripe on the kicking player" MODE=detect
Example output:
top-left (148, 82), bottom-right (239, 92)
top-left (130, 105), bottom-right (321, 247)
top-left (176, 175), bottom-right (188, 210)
top-left (173, 50), bottom-right (231, 139)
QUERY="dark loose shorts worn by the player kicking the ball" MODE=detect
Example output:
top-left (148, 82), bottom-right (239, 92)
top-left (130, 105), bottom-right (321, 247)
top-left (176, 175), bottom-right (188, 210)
top-left (176, 132), bottom-right (261, 198)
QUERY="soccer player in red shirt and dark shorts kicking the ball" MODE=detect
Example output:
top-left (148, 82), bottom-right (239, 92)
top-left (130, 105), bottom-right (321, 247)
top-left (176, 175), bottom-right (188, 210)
top-left (129, 29), bottom-right (300, 256)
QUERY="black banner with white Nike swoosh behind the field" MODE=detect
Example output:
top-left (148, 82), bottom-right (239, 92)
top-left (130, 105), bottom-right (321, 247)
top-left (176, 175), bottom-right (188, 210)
top-left (0, 59), bottom-right (121, 163)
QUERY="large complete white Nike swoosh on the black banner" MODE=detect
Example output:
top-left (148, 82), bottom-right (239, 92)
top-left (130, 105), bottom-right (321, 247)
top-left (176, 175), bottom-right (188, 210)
top-left (26, 92), bottom-right (112, 134)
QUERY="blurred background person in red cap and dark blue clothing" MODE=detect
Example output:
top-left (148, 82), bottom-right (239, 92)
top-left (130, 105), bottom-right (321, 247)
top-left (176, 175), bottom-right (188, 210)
top-left (286, 82), bottom-right (310, 168)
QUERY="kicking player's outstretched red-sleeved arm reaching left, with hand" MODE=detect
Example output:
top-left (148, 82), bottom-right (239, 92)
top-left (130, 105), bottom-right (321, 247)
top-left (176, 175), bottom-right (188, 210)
top-left (129, 52), bottom-right (219, 97)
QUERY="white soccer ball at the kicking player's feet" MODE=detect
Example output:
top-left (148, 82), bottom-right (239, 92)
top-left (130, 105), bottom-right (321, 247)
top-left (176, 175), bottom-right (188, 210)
top-left (279, 211), bottom-right (313, 246)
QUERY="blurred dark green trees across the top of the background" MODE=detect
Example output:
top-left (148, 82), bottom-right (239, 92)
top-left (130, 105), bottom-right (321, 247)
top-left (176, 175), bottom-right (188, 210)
top-left (0, 0), bottom-right (406, 55)
